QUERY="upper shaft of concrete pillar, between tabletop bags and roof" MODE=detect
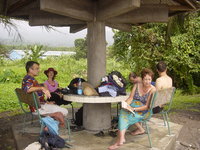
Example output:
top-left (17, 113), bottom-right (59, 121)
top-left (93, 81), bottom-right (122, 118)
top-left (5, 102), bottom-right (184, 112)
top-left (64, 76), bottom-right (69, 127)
top-left (87, 22), bottom-right (106, 87)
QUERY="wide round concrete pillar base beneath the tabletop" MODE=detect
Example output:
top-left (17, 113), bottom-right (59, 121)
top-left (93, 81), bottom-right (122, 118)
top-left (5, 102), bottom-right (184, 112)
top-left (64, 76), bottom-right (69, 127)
top-left (83, 103), bottom-right (111, 131)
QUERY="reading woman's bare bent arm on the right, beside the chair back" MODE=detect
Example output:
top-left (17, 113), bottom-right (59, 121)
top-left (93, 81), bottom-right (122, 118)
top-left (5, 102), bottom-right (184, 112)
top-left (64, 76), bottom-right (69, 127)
top-left (131, 87), bottom-right (156, 111)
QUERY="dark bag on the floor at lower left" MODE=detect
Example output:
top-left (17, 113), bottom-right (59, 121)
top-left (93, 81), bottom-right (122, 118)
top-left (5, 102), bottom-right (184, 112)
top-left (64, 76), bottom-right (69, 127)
top-left (39, 131), bottom-right (65, 150)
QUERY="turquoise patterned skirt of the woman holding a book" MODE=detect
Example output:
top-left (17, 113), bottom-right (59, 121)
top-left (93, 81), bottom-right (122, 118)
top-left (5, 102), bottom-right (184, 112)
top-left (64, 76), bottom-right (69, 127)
top-left (118, 100), bottom-right (148, 130)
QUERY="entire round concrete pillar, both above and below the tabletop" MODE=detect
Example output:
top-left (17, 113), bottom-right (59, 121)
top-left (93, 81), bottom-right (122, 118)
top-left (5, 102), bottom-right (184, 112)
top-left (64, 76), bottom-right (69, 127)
top-left (83, 22), bottom-right (111, 131)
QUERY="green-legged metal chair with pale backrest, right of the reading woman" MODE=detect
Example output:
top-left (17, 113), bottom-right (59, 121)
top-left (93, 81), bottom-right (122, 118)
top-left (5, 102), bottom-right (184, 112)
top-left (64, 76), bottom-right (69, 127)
top-left (142, 87), bottom-right (175, 148)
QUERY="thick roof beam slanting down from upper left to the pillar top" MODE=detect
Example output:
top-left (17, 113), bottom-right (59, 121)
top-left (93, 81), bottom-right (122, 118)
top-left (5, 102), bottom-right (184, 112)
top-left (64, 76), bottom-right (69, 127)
top-left (40, 0), bottom-right (93, 21)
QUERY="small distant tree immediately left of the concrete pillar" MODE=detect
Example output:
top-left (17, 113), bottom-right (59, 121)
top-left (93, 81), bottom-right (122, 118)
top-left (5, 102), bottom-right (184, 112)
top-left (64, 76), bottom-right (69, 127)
top-left (74, 38), bottom-right (87, 59)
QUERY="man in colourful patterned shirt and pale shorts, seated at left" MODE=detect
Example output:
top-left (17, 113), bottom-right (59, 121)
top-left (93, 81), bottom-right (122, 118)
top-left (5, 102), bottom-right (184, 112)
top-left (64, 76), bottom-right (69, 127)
top-left (22, 61), bottom-right (68, 121)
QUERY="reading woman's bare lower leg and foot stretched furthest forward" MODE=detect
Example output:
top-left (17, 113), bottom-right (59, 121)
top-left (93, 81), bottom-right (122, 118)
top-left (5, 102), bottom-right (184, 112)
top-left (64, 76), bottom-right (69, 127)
top-left (108, 129), bottom-right (126, 150)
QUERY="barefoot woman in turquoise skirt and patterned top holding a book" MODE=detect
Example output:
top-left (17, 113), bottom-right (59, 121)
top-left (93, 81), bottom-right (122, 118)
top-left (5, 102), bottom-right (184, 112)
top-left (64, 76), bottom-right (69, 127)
top-left (108, 69), bottom-right (156, 150)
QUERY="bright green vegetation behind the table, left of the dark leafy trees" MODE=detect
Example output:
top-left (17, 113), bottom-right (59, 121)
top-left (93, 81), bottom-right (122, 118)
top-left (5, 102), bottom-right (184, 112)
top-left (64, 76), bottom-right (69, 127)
top-left (0, 56), bottom-right (129, 112)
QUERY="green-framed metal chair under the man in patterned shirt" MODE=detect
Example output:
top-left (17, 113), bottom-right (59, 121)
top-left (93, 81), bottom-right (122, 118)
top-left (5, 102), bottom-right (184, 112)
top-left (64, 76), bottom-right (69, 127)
top-left (15, 88), bottom-right (71, 141)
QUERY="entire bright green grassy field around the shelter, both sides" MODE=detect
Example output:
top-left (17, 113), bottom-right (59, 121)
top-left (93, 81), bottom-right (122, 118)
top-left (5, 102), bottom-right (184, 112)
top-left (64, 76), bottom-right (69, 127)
top-left (0, 56), bottom-right (200, 113)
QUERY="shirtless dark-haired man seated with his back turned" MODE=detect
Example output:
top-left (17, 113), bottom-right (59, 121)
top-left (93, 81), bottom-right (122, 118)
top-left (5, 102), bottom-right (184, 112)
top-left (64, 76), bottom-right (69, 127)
top-left (153, 61), bottom-right (172, 114)
